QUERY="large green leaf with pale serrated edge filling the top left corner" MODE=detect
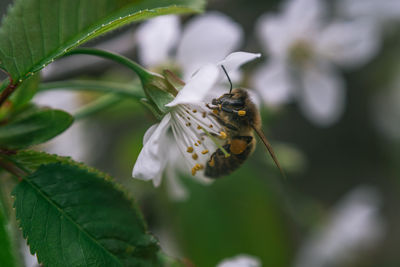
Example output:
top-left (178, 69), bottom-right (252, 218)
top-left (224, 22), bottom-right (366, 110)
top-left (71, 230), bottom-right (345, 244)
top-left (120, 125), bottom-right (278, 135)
top-left (0, 0), bottom-right (204, 83)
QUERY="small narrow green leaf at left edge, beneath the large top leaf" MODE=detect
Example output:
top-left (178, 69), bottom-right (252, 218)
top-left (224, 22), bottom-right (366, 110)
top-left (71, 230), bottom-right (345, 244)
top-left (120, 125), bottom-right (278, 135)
top-left (11, 74), bottom-right (40, 110)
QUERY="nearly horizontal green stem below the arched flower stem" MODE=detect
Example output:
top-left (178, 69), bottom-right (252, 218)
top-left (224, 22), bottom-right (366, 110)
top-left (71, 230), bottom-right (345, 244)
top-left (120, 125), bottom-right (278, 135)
top-left (38, 81), bottom-right (144, 100)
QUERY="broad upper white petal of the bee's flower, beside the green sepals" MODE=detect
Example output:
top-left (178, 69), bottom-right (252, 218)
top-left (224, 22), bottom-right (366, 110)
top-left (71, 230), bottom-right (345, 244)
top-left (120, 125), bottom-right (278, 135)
top-left (166, 64), bottom-right (219, 107)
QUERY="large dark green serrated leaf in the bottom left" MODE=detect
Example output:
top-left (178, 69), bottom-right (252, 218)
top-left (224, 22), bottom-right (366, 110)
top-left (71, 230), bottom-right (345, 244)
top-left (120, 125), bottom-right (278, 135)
top-left (13, 160), bottom-right (160, 266)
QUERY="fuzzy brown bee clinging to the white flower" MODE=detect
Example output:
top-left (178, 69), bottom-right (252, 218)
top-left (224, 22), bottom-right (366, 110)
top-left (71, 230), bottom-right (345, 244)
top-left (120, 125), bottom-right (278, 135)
top-left (204, 66), bottom-right (284, 178)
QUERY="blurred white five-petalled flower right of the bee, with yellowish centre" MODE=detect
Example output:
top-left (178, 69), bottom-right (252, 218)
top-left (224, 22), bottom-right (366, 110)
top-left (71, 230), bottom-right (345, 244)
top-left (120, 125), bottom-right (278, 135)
top-left (252, 0), bottom-right (378, 126)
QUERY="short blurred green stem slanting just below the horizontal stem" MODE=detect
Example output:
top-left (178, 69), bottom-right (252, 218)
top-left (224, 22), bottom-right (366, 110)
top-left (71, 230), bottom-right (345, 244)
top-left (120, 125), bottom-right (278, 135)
top-left (74, 94), bottom-right (123, 120)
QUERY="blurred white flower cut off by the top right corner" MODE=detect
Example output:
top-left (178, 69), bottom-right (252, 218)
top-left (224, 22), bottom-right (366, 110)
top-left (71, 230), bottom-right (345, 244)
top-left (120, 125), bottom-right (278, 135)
top-left (339, 0), bottom-right (400, 24)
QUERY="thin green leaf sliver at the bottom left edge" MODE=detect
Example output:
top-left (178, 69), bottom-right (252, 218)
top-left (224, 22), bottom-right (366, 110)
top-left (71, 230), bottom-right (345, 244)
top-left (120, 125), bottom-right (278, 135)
top-left (0, 197), bottom-right (18, 267)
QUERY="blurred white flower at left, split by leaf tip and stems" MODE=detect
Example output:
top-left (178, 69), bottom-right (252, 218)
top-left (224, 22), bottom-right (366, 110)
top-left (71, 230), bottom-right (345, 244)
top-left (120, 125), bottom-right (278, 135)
top-left (34, 90), bottom-right (90, 162)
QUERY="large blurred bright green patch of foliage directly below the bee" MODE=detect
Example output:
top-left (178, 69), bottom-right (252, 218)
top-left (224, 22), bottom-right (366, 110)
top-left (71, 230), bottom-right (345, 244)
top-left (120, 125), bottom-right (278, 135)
top-left (168, 163), bottom-right (290, 266)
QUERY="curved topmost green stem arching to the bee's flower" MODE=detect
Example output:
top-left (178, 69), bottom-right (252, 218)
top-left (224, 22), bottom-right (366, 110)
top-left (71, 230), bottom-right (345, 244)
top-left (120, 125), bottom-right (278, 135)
top-left (64, 48), bottom-right (154, 81)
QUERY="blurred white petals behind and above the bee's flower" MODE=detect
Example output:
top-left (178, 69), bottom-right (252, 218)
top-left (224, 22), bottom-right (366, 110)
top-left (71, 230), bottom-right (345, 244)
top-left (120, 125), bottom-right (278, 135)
top-left (136, 12), bottom-right (243, 80)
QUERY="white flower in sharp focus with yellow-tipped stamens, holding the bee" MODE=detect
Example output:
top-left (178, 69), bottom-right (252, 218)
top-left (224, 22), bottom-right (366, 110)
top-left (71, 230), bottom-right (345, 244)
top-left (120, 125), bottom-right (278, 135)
top-left (132, 52), bottom-right (260, 186)
